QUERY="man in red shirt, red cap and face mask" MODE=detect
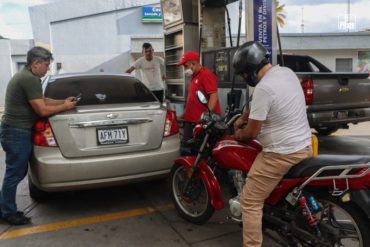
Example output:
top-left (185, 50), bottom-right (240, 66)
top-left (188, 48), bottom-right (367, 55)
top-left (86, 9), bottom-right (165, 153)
top-left (177, 51), bottom-right (221, 147)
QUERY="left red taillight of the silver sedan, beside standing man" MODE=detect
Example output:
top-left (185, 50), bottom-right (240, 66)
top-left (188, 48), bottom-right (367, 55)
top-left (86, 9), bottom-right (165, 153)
top-left (32, 120), bottom-right (58, 147)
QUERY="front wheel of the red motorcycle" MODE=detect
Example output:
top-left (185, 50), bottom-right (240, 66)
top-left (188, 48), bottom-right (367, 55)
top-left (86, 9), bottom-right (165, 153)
top-left (170, 164), bottom-right (214, 224)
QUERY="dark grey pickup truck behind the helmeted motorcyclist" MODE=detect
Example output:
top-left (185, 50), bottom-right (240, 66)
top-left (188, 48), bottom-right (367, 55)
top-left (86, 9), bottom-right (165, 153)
top-left (278, 54), bottom-right (370, 135)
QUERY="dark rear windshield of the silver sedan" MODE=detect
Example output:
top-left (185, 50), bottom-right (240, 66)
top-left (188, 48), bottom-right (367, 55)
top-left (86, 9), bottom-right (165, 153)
top-left (44, 75), bottom-right (156, 105)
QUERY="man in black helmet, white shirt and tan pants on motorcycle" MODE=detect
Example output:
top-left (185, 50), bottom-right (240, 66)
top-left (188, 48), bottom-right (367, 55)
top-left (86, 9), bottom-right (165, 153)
top-left (233, 41), bottom-right (312, 247)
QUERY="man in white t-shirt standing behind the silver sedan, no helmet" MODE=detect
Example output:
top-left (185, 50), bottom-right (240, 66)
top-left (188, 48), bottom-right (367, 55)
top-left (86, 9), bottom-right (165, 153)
top-left (126, 43), bottom-right (165, 102)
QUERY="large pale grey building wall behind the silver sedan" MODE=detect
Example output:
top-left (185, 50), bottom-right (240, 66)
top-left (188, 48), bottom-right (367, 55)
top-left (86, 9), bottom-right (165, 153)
top-left (30, 0), bottom-right (163, 73)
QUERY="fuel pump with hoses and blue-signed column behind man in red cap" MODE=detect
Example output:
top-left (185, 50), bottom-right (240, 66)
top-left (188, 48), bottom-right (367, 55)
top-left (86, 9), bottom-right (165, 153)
top-left (161, 0), bottom-right (276, 110)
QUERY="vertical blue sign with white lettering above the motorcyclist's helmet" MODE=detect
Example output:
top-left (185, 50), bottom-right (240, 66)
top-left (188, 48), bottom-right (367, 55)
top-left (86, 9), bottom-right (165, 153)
top-left (253, 0), bottom-right (272, 62)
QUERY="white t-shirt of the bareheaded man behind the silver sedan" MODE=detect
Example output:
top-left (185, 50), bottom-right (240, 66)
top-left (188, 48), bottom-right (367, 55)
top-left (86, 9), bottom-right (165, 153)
top-left (132, 56), bottom-right (164, 90)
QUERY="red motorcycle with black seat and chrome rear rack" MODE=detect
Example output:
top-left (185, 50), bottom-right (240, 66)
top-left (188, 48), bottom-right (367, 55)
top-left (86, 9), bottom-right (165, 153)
top-left (170, 92), bottom-right (370, 247)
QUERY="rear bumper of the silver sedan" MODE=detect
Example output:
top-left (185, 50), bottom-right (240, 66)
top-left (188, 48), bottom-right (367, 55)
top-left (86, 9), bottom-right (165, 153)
top-left (29, 135), bottom-right (180, 191)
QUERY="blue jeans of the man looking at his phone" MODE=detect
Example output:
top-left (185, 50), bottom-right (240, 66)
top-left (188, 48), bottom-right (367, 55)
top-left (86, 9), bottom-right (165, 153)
top-left (0, 123), bottom-right (32, 216)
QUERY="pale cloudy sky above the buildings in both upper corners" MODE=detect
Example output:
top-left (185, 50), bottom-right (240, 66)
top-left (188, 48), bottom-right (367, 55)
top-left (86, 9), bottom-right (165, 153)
top-left (0, 0), bottom-right (370, 39)
